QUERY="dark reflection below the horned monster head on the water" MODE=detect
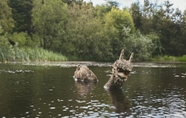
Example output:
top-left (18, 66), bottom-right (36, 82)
top-left (106, 89), bottom-right (131, 117)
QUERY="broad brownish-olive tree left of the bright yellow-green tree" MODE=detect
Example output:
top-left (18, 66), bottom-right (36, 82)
top-left (60, 3), bottom-right (111, 60)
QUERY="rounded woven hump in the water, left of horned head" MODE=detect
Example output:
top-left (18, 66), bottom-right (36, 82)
top-left (73, 65), bottom-right (98, 83)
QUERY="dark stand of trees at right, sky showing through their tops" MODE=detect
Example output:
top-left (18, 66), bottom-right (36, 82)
top-left (130, 0), bottom-right (186, 56)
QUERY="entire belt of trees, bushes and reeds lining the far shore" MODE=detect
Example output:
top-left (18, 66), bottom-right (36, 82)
top-left (0, 0), bottom-right (186, 61)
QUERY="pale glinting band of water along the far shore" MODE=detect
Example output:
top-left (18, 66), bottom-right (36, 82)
top-left (0, 61), bottom-right (186, 68)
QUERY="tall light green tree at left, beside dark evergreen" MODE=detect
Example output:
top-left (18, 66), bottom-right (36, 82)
top-left (32, 0), bottom-right (67, 50)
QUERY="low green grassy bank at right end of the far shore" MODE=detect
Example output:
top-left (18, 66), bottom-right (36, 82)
top-left (151, 55), bottom-right (186, 62)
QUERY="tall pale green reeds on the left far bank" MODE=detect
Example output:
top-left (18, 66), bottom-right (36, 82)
top-left (0, 47), bottom-right (67, 62)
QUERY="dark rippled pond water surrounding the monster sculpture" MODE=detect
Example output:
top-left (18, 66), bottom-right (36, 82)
top-left (0, 63), bottom-right (186, 118)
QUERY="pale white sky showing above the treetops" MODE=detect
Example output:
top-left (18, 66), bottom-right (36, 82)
top-left (84, 0), bottom-right (186, 11)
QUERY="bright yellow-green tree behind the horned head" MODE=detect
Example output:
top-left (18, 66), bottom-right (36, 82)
top-left (104, 8), bottom-right (135, 57)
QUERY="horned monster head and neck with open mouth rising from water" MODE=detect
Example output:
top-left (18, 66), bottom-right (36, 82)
top-left (104, 50), bottom-right (134, 89)
